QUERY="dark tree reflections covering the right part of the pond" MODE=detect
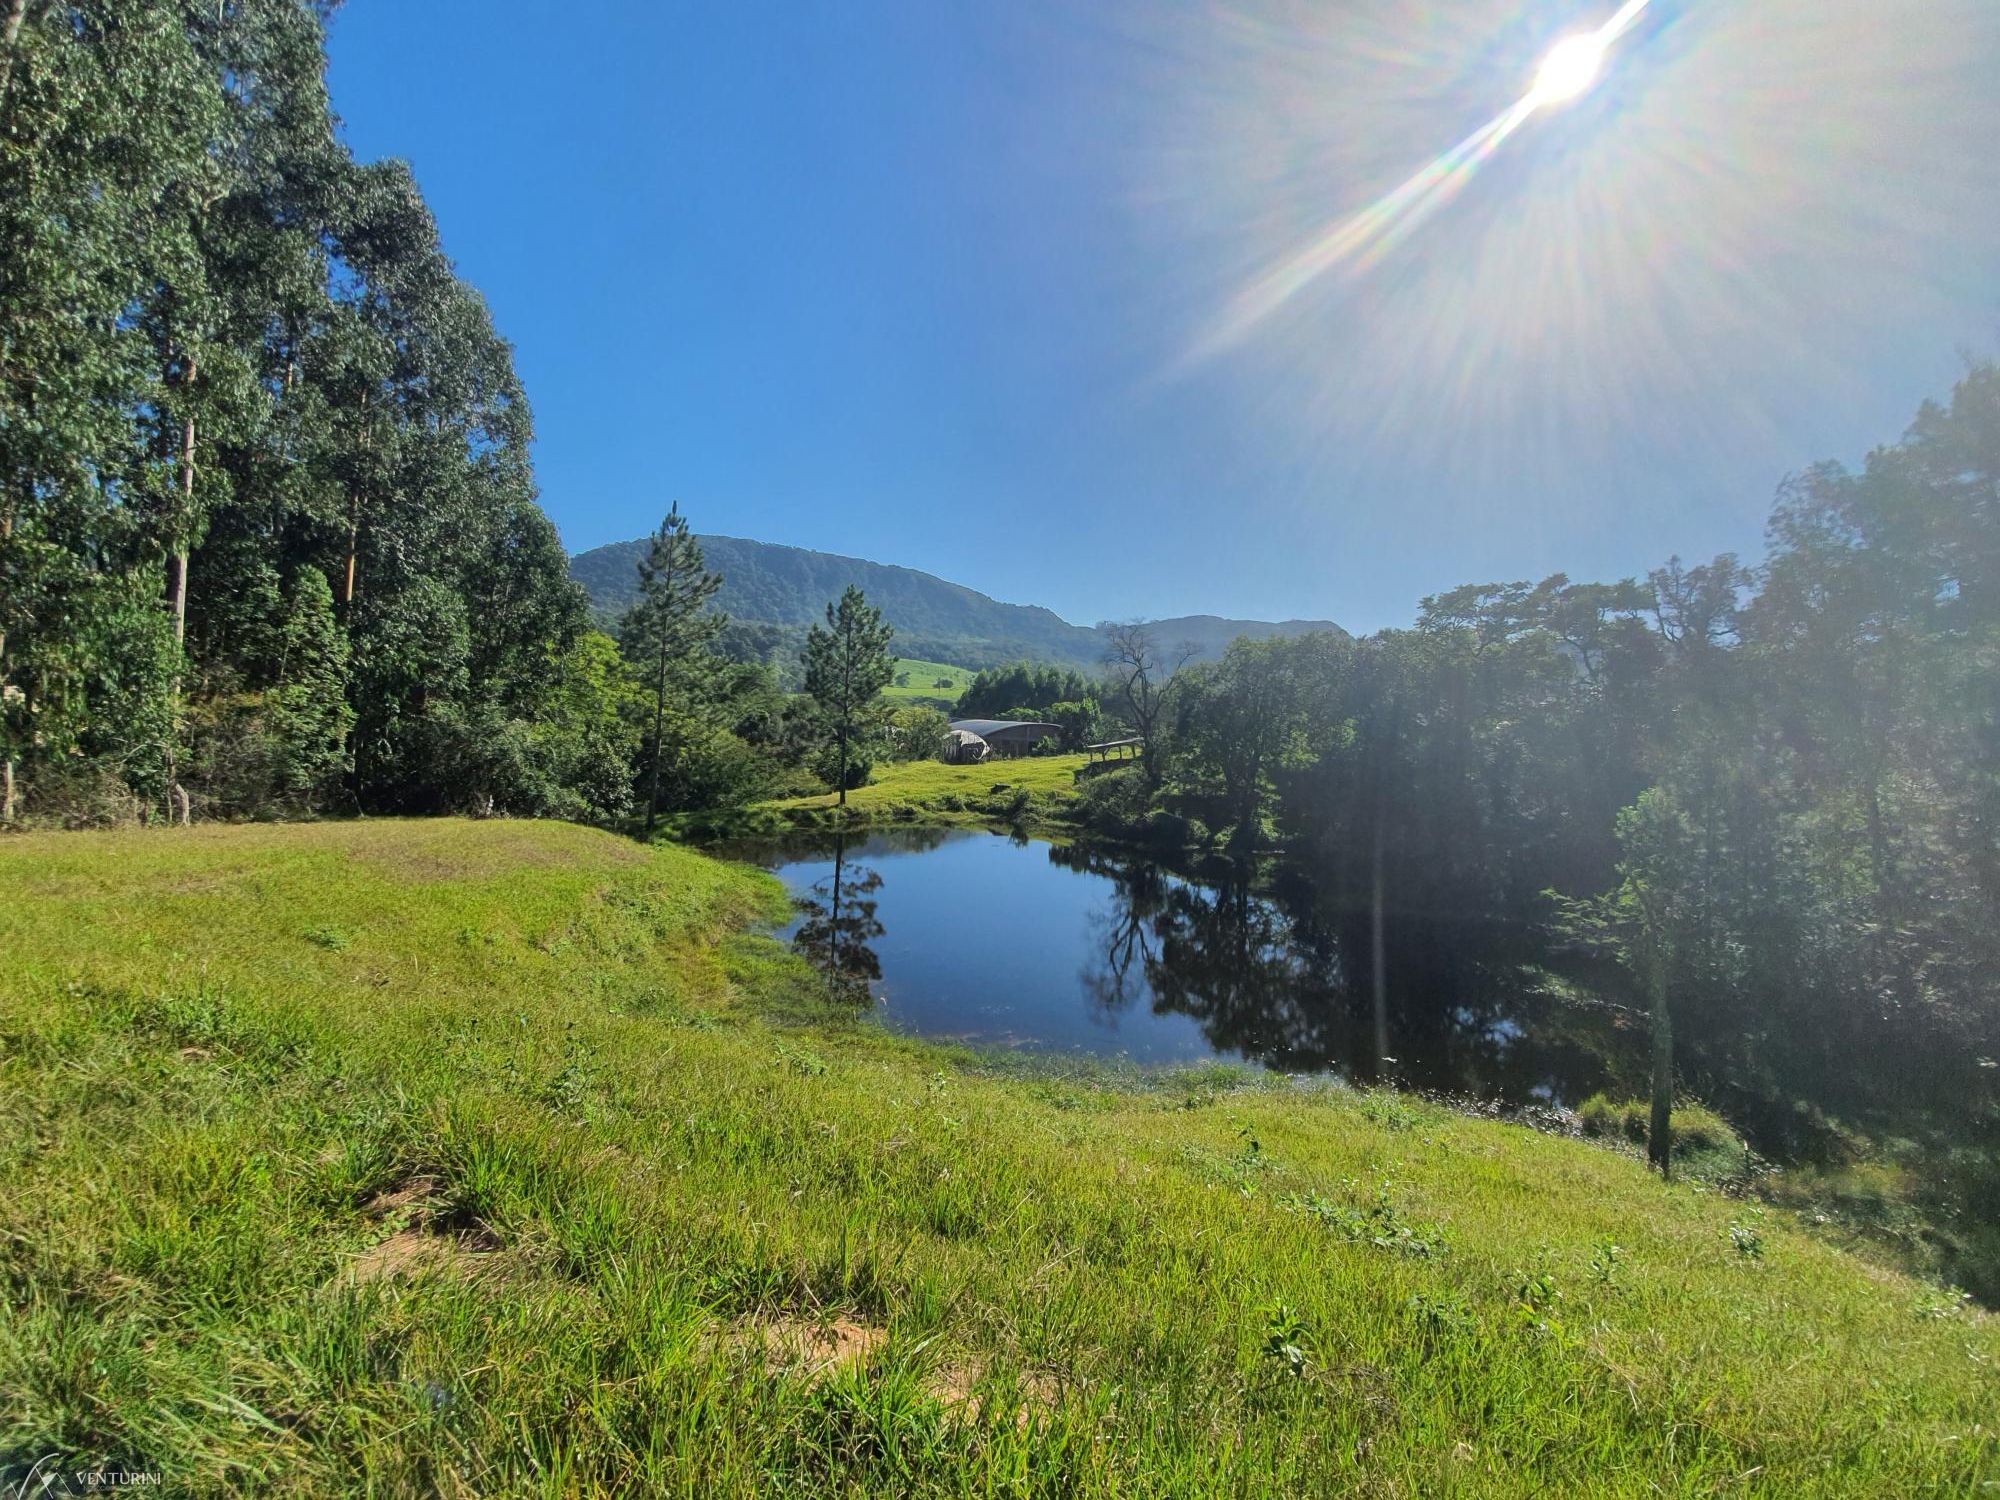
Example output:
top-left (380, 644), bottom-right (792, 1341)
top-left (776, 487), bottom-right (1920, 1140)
top-left (1050, 848), bottom-right (1636, 1102)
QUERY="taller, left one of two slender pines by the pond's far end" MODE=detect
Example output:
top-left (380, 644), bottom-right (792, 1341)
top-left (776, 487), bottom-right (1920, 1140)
top-left (618, 504), bottom-right (726, 832)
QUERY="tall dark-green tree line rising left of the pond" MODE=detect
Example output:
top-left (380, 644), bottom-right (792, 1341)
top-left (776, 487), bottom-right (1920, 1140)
top-left (0, 0), bottom-right (908, 824)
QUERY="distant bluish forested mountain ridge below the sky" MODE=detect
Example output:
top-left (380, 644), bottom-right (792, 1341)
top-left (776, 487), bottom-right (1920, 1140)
top-left (570, 536), bottom-right (1346, 666)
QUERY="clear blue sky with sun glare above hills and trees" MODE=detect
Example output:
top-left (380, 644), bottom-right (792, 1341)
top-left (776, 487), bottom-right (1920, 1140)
top-left (332, 0), bottom-right (2000, 630)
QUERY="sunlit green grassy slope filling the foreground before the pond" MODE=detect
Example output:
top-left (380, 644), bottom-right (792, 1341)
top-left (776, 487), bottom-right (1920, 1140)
top-left (0, 824), bottom-right (2000, 1498)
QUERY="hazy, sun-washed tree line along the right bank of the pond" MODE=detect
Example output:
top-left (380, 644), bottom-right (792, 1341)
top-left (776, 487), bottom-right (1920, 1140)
top-left (1084, 366), bottom-right (2000, 1192)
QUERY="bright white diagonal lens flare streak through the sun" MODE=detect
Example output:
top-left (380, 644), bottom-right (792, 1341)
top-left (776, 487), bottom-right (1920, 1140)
top-left (1194, 0), bottom-right (1650, 358)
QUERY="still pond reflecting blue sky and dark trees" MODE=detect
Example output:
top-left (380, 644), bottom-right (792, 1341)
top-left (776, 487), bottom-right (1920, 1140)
top-left (718, 828), bottom-right (1640, 1104)
